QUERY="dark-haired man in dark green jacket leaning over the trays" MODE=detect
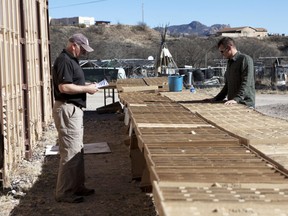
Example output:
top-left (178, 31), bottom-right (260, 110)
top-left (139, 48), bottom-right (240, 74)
top-left (207, 37), bottom-right (255, 108)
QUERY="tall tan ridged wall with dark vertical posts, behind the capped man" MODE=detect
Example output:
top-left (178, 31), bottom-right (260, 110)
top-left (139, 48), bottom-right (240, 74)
top-left (0, 0), bottom-right (52, 187)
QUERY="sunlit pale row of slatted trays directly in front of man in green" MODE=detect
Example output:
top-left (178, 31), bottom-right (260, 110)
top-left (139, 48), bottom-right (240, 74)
top-left (164, 93), bottom-right (288, 170)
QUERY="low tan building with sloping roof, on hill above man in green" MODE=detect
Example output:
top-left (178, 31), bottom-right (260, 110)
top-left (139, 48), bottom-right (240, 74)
top-left (217, 26), bottom-right (268, 38)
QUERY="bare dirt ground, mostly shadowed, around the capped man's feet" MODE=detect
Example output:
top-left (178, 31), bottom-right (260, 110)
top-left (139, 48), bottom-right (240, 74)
top-left (0, 89), bottom-right (288, 216)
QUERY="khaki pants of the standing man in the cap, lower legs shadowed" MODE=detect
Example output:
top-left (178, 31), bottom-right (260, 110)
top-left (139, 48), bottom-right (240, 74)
top-left (53, 101), bottom-right (85, 198)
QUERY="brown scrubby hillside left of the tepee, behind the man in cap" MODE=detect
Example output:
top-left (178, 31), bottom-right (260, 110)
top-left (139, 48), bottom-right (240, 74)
top-left (50, 24), bottom-right (161, 62)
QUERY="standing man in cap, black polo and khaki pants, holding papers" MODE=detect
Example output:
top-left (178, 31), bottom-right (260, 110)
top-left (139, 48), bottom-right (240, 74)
top-left (53, 33), bottom-right (98, 203)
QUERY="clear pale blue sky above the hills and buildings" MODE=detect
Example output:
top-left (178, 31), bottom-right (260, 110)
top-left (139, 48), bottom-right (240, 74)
top-left (49, 0), bottom-right (288, 35)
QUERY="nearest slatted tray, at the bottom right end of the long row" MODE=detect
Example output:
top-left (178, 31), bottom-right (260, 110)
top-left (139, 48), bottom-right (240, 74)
top-left (153, 181), bottom-right (288, 216)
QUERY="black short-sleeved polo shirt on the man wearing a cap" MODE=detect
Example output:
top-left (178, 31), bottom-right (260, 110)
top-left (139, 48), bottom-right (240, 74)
top-left (53, 50), bottom-right (86, 107)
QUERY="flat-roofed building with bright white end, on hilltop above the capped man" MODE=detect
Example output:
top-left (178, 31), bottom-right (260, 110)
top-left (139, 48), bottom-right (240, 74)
top-left (50, 17), bottom-right (95, 26)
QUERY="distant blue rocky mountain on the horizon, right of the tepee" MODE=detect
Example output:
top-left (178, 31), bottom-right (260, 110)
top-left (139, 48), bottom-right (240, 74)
top-left (154, 21), bottom-right (230, 36)
